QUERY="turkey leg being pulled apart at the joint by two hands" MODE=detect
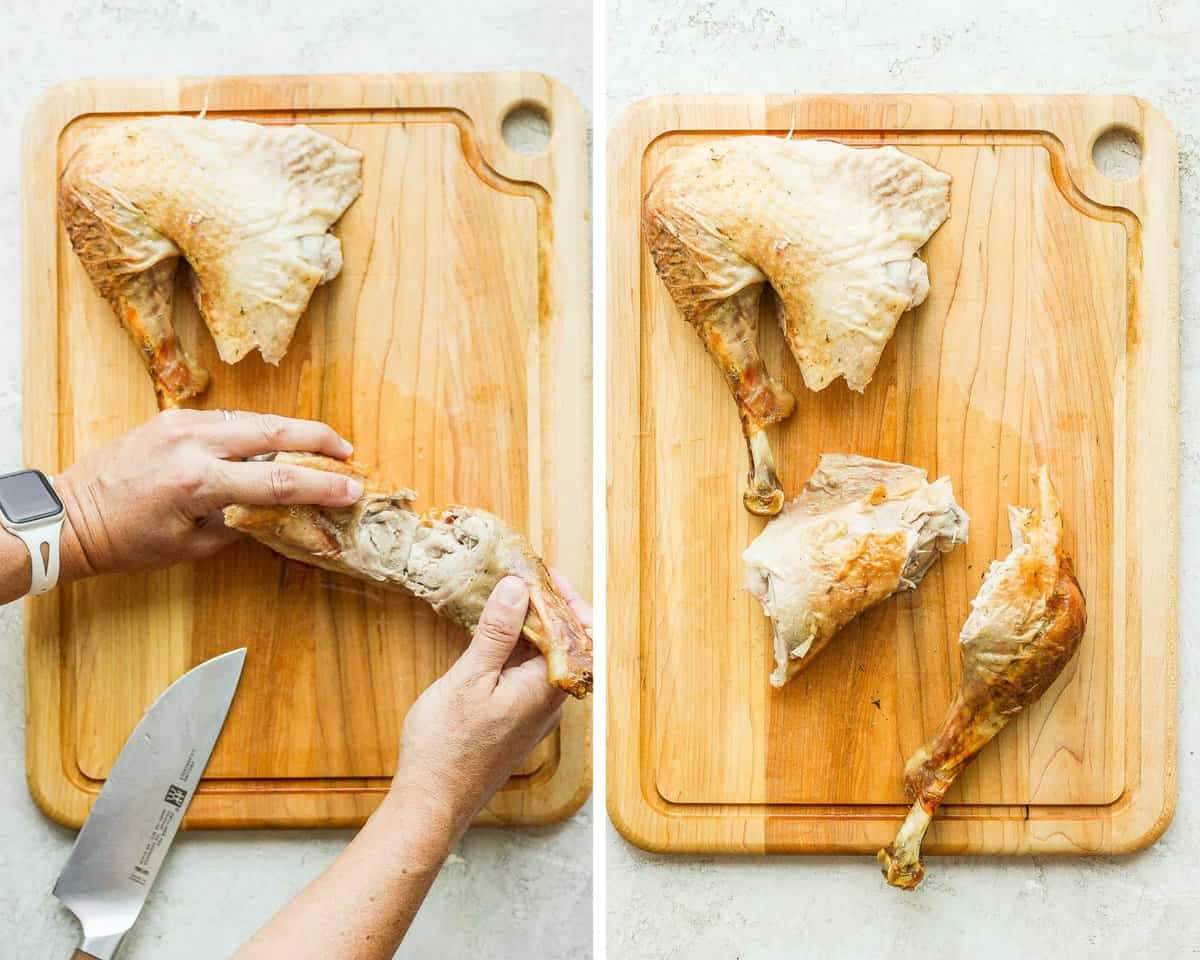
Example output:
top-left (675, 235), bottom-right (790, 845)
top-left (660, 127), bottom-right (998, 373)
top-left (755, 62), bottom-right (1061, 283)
top-left (224, 454), bottom-right (592, 698)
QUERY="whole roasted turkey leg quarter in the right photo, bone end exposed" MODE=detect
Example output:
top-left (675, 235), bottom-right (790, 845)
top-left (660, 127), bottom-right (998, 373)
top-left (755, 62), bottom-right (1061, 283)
top-left (642, 137), bottom-right (950, 516)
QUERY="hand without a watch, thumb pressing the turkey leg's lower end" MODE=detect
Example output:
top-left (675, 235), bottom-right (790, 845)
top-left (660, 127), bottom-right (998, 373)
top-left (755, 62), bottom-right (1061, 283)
top-left (388, 572), bottom-right (592, 846)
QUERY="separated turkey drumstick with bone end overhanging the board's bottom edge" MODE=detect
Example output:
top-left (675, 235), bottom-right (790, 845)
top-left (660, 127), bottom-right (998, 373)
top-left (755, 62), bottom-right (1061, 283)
top-left (877, 467), bottom-right (1087, 890)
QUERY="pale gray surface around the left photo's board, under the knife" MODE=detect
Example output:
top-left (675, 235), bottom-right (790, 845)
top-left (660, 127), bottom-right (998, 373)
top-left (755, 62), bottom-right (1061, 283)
top-left (0, 0), bottom-right (592, 960)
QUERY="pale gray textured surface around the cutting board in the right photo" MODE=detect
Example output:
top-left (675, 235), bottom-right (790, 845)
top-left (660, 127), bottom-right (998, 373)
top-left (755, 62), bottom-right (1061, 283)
top-left (608, 0), bottom-right (1200, 960)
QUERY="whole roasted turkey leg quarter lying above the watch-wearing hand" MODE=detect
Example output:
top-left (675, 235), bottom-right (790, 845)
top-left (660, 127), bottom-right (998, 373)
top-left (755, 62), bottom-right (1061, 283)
top-left (59, 116), bottom-right (362, 407)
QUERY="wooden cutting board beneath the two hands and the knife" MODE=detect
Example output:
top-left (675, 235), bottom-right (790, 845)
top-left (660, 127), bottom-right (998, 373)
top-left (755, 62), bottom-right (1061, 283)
top-left (24, 73), bottom-right (592, 827)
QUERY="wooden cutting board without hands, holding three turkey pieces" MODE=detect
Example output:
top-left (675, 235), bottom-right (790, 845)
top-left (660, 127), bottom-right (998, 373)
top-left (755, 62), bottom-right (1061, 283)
top-left (608, 96), bottom-right (1180, 853)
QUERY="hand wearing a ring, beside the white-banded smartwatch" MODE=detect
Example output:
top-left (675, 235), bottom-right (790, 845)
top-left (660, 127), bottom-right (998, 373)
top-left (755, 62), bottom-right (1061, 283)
top-left (54, 409), bottom-right (362, 580)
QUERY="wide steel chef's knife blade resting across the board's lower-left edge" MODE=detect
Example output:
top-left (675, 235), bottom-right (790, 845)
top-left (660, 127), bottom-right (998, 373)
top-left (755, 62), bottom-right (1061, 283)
top-left (54, 647), bottom-right (246, 960)
